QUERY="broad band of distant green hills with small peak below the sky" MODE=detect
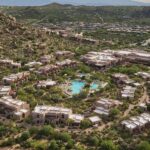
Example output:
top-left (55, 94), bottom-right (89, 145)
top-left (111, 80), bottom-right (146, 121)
top-left (1, 3), bottom-right (150, 25)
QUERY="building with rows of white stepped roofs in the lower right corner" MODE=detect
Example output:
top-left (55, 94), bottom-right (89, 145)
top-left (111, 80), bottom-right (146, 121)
top-left (121, 113), bottom-right (150, 133)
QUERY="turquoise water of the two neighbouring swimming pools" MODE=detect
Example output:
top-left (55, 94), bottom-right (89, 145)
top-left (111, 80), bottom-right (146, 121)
top-left (71, 80), bottom-right (99, 95)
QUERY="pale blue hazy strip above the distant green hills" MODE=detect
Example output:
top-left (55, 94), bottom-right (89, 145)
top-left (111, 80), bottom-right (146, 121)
top-left (0, 0), bottom-right (150, 6)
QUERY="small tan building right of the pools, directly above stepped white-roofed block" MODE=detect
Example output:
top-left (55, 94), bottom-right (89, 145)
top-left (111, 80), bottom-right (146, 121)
top-left (112, 73), bottom-right (134, 85)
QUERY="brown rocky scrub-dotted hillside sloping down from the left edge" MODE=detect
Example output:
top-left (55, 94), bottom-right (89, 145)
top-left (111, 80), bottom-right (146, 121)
top-left (0, 13), bottom-right (89, 62)
